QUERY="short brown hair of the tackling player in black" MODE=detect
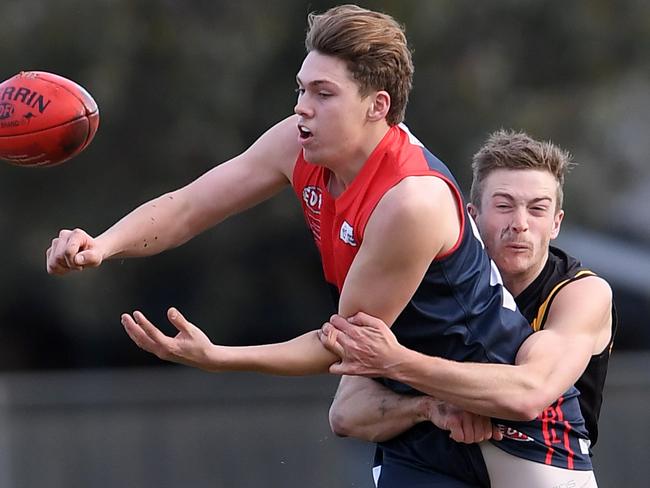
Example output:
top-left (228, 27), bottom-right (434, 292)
top-left (470, 129), bottom-right (574, 211)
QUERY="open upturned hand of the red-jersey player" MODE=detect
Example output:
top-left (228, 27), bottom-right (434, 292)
top-left (122, 308), bottom-right (214, 371)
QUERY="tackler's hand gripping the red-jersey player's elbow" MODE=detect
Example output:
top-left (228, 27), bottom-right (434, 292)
top-left (319, 312), bottom-right (403, 377)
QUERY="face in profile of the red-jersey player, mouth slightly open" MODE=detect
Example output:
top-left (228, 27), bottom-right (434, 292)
top-left (294, 51), bottom-right (372, 168)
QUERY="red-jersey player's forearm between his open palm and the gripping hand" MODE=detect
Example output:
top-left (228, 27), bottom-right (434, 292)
top-left (208, 331), bottom-right (338, 376)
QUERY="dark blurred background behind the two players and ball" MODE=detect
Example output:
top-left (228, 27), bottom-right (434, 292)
top-left (0, 0), bottom-right (650, 488)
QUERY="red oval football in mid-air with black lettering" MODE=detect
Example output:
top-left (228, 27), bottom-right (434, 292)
top-left (0, 71), bottom-right (99, 166)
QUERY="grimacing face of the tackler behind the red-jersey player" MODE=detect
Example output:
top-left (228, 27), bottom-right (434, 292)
top-left (472, 169), bottom-right (564, 288)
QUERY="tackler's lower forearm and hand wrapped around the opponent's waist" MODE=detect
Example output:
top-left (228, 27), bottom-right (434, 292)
top-left (329, 376), bottom-right (502, 444)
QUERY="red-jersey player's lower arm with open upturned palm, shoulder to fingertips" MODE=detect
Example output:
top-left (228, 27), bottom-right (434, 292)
top-left (122, 162), bottom-right (458, 375)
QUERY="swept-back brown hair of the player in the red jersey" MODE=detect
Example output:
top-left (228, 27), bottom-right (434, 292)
top-left (305, 5), bottom-right (413, 125)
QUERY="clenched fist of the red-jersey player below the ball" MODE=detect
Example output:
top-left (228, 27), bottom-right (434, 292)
top-left (45, 229), bottom-right (104, 275)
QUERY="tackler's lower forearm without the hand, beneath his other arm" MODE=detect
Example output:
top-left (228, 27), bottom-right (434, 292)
top-left (329, 376), bottom-right (429, 442)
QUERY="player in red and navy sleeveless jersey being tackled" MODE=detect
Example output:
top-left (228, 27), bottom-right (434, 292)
top-left (46, 5), bottom-right (591, 488)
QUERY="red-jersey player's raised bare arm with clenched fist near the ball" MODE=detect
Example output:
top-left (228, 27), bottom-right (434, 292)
top-left (46, 116), bottom-right (300, 275)
